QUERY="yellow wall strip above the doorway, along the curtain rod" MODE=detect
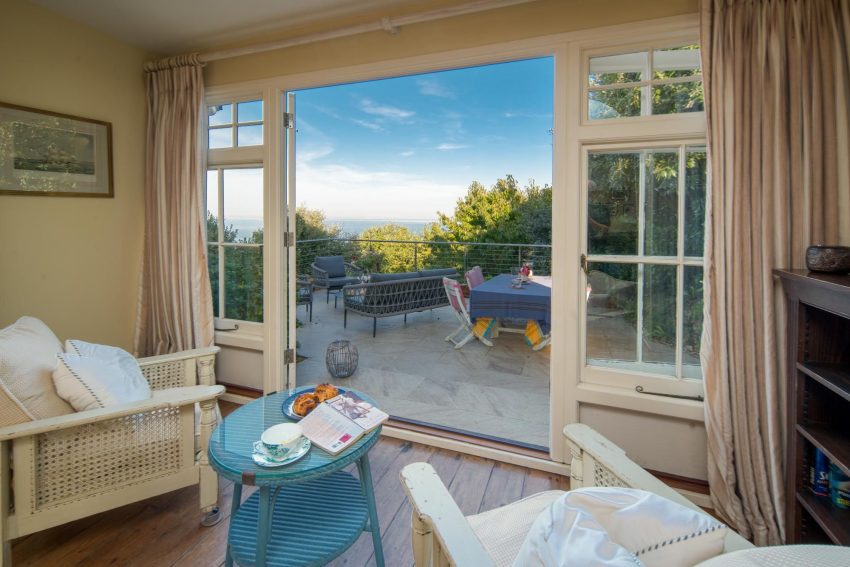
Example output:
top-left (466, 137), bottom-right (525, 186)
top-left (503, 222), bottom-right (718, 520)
top-left (206, 0), bottom-right (698, 86)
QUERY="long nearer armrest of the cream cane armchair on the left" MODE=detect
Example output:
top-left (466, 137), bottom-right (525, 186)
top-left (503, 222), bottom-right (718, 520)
top-left (0, 386), bottom-right (224, 441)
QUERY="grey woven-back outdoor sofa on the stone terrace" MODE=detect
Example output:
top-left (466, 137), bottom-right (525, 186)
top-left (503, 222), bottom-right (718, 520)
top-left (342, 268), bottom-right (458, 337)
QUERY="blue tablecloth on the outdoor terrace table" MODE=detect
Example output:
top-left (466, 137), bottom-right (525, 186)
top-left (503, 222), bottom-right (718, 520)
top-left (469, 274), bottom-right (552, 333)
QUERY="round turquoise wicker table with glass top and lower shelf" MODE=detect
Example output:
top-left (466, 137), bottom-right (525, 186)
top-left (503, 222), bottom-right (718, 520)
top-left (209, 388), bottom-right (384, 567)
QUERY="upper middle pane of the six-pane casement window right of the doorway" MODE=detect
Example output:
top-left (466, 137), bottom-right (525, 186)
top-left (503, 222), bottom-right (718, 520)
top-left (644, 150), bottom-right (679, 256)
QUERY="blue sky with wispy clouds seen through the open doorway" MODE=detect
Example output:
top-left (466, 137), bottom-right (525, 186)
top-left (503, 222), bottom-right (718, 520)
top-left (296, 57), bottom-right (554, 220)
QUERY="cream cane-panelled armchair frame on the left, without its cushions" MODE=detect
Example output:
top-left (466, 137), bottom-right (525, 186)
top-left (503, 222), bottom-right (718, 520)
top-left (0, 347), bottom-right (224, 566)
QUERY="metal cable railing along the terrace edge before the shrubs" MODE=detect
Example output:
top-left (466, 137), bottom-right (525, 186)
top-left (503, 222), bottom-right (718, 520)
top-left (295, 238), bottom-right (552, 277)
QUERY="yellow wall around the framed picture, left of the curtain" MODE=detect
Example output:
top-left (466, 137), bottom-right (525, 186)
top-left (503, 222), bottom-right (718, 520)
top-left (0, 0), bottom-right (147, 348)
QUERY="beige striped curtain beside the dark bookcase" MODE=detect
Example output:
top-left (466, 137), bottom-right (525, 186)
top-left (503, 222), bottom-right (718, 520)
top-left (701, 0), bottom-right (850, 545)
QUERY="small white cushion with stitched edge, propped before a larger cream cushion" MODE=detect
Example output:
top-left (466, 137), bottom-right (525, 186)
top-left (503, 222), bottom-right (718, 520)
top-left (53, 340), bottom-right (151, 411)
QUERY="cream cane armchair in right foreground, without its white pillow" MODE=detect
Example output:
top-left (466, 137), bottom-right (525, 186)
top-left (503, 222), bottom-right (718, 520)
top-left (401, 423), bottom-right (753, 567)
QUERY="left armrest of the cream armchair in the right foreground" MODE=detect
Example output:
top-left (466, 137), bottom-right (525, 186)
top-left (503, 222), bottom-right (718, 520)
top-left (400, 463), bottom-right (495, 567)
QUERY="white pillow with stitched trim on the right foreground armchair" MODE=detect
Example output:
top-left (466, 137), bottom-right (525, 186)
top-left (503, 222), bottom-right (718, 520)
top-left (514, 488), bottom-right (726, 567)
